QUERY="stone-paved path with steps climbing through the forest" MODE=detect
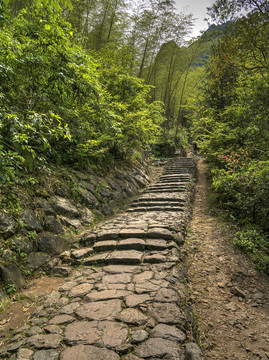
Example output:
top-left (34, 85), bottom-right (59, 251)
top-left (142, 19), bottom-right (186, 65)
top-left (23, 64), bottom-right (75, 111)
top-left (0, 158), bottom-right (203, 360)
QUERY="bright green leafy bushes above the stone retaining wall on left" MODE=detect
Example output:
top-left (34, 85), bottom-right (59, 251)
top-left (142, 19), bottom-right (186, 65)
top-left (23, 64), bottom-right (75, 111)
top-left (0, 7), bottom-right (163, 184)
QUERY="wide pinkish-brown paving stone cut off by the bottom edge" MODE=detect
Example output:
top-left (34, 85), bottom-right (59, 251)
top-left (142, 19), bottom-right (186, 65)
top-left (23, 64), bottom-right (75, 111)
top-left (60, 345), bottom-right (120, 360)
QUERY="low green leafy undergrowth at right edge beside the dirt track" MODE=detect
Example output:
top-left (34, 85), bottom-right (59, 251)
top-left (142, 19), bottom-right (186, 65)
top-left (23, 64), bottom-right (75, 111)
top-left (233, 228), bottom-right (269, 274)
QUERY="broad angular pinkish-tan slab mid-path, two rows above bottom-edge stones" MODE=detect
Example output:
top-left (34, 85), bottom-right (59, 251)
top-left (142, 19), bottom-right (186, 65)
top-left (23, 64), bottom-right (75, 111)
top-left (76, 299), bottom-right (121, 320)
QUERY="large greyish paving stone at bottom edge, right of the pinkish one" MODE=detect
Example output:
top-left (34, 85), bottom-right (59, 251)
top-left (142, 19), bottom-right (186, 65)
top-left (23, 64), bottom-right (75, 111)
top-left (135, 338), bottom-right (184, 360)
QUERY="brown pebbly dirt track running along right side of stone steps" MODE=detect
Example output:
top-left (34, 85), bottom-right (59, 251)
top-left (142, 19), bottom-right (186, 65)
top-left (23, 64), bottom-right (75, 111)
top-left (186, 160), bottom-right (269, 360)
